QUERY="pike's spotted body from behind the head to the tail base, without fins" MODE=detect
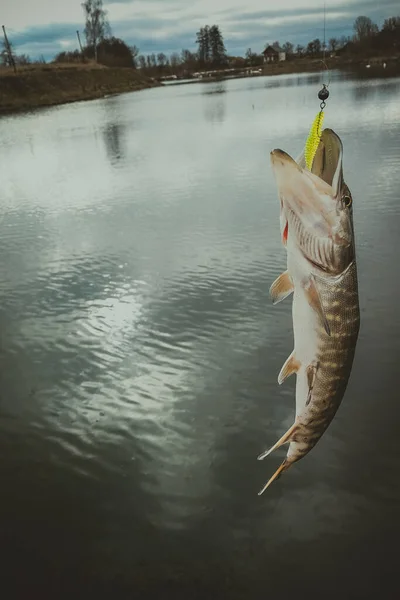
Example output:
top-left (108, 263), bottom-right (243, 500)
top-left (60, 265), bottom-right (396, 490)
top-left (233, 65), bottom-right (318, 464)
top-left (287, 259), bottom-right (360, 463)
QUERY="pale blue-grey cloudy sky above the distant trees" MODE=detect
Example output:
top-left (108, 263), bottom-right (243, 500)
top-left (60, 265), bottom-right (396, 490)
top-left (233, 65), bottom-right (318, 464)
top-left (0, 0), bottom-right (400, 59)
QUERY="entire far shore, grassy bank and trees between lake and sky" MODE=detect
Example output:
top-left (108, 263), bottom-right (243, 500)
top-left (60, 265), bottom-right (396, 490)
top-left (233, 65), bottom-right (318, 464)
top-left (0, 0), bottom-right (400, 112)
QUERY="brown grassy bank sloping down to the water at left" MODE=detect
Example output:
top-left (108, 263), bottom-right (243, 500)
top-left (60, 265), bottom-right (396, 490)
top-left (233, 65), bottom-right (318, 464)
top-left (0, 65), bottom-right (160, 114)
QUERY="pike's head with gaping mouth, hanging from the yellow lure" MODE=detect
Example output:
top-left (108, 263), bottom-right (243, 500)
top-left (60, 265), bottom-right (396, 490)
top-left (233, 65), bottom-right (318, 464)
top-left (271, 129), bottom-right (355, 275)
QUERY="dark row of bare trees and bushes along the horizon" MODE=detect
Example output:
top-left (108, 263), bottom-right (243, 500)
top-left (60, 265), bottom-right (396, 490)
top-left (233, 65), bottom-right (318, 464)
top-left (0, 0), bottom-right (400, 78)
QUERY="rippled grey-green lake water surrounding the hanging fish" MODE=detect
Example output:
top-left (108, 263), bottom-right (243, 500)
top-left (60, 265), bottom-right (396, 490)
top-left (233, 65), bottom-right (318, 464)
top-left (0, 73), bottom-right (400, 600)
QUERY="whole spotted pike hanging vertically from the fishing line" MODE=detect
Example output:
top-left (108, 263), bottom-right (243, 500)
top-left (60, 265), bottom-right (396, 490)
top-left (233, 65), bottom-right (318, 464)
top-left (258, 129), bottom-right (360, 495)
